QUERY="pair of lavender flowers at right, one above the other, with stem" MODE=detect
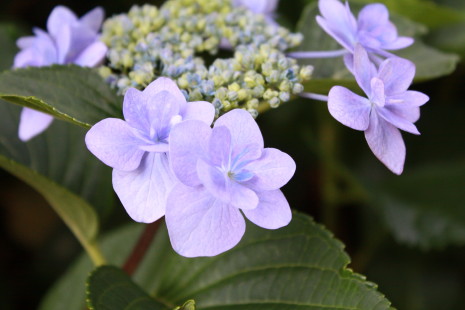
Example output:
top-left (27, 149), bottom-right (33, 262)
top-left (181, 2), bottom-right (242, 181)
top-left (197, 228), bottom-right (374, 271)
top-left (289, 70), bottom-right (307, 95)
top-left (295, 0), bottom-right (429, 174)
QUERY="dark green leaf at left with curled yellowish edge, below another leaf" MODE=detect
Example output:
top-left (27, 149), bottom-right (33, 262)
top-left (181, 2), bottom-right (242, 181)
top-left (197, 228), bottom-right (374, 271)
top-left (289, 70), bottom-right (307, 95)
top-left (0, 102), bottom-right (113, 264)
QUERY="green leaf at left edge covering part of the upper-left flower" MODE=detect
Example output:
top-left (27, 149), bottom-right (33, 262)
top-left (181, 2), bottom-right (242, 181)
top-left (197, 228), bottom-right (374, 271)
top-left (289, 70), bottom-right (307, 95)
top-left (0, 65), bottom-right (122, 128)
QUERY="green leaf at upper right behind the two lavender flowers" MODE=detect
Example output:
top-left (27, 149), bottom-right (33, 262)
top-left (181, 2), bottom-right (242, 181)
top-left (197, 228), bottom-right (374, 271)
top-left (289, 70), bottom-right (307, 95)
top-left (297, 3), bottom-right (459, 93)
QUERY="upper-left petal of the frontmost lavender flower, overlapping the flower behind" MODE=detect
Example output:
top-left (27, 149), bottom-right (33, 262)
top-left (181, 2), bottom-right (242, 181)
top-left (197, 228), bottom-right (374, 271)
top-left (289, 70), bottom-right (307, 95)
top-left (169, 120), bottom-right (212, 186)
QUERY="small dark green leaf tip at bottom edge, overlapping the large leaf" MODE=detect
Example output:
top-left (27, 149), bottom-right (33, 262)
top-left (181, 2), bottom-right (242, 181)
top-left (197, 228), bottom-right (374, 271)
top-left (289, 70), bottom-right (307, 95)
top-left (87, 266), bottom-right (166, 310)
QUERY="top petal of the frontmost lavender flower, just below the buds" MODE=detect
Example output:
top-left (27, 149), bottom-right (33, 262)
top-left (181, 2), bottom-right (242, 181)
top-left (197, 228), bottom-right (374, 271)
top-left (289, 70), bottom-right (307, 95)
top-left (215, 109), bottom-right (263, 149)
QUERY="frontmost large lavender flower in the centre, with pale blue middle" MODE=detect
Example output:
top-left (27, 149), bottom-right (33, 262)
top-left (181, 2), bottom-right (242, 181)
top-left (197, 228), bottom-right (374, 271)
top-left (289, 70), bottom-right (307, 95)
top-left (165, 109), bottom-right (295, 257)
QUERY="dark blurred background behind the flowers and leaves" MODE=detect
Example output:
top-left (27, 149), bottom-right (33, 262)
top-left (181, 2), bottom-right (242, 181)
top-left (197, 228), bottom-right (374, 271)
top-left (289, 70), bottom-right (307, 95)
top-left (0, 0), bottom-right (465, 310)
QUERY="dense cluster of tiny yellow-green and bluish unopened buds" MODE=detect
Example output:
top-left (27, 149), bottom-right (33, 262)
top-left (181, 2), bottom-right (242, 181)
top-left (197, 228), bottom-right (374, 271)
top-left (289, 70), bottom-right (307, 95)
top-left (100, 0), bottom-right (312, 116)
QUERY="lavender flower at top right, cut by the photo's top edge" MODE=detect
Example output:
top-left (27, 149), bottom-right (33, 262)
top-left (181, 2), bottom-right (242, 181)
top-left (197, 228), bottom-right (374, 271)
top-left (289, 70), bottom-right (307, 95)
top-left (316, 0), bottom-right (413, 65)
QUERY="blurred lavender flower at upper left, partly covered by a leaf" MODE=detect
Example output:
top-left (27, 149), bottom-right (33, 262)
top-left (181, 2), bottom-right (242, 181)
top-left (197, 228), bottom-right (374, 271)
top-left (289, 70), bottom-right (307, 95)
top-left (14, 6), bottom-right (107, 141)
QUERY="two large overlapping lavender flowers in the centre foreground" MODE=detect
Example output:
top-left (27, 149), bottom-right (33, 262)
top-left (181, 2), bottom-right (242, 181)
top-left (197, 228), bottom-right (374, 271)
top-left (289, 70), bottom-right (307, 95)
top-left (86, 78), bottom-right (295, 257)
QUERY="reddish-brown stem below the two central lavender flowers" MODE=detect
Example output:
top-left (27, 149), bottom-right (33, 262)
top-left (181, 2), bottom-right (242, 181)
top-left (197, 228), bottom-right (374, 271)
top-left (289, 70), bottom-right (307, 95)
top-left (123, 220), bottom-right (162, 276)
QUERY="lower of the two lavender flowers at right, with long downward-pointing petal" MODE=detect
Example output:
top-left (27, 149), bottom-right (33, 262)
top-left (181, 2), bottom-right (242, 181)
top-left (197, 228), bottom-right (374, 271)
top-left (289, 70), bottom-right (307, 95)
top-left (328, 45), bottom-right (429, 174)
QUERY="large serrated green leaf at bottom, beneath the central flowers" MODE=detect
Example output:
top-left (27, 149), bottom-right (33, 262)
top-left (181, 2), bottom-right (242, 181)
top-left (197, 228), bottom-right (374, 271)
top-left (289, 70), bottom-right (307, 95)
top-left (42, 214), bottom-right (390, 310)
